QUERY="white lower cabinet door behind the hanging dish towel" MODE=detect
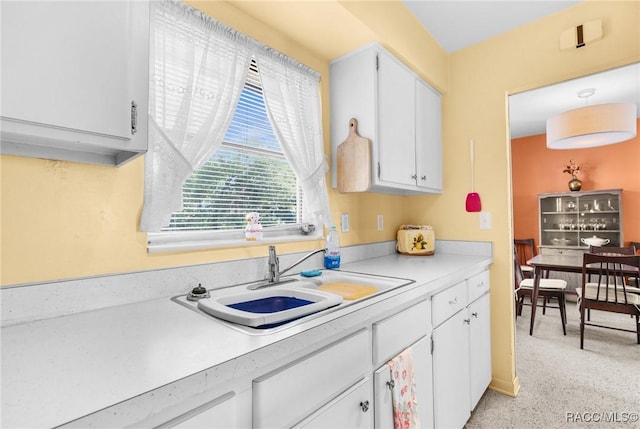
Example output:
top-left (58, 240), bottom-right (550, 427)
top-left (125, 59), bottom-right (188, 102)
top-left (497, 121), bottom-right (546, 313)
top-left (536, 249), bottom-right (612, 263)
top-left (373, 337), bottom-right (433, 429)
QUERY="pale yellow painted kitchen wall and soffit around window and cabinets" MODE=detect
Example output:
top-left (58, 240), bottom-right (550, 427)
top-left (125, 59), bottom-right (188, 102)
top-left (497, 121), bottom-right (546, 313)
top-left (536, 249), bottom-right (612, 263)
top-left (0, 0), bottom-right (640, 394)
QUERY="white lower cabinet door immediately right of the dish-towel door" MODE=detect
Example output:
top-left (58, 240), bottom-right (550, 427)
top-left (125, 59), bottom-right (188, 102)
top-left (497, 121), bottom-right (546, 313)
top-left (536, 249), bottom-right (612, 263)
top-left (433, 310), bottom-right (471, 428)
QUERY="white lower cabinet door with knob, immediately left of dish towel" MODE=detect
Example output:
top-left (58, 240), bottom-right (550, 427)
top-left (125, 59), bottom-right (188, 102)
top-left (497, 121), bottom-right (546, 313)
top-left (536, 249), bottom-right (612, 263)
top-left (294, 378), bottom-right (376, 429)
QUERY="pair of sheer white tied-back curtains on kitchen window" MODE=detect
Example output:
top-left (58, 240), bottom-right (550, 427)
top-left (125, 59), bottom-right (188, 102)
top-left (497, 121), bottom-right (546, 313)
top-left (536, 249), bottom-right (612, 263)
top-left (140, 0), bottom-right (332, 232)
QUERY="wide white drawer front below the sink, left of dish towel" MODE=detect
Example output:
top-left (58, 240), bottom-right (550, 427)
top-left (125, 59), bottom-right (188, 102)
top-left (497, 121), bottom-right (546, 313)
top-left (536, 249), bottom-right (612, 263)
top-left (253, 330), bottom-right (371, 428)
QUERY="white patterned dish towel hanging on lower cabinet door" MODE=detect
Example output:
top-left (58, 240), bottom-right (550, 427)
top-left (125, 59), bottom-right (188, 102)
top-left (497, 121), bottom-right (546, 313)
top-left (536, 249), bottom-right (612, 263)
top-left (388, 348), bottom-right (420, 429)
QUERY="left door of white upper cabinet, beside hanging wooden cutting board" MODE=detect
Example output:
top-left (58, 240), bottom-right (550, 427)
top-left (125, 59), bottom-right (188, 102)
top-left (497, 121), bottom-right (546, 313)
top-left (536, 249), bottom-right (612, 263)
top-left (376, 51), bottom-right (416, 186)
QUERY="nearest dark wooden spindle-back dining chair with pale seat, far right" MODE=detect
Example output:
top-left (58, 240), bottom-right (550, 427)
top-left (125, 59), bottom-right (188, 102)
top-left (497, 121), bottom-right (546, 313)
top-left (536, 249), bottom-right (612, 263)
top-left (576, 253), bottom-right (640, 349)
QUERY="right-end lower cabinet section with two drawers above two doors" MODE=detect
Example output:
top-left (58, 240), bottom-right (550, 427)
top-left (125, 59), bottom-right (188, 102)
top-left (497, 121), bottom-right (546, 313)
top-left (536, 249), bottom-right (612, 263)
top-left (432, 271), bottom-right (491, 428)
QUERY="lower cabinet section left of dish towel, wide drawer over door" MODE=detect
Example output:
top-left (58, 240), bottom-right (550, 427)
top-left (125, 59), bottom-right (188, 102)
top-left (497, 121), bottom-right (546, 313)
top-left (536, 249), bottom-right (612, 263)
top-left (253, 329), bottom-right (373, 428)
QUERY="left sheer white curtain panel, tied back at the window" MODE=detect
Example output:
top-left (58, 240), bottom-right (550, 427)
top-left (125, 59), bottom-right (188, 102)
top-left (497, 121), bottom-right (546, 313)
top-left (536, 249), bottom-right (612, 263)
top-left (140, 1), bottom-right (256, 232)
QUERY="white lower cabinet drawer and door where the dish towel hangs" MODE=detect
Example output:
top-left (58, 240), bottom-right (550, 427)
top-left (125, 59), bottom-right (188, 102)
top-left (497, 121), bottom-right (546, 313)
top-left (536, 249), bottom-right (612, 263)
top-left (373, 301), bottom-right (433, 429)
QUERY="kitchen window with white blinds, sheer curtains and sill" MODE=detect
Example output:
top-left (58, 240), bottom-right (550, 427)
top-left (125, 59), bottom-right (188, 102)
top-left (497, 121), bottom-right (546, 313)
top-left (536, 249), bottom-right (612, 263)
top-left (141, 1), bottom-right (331, 252)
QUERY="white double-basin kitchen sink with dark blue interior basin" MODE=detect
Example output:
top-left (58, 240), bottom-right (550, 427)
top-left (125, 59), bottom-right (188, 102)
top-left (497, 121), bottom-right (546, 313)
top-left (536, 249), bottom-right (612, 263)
top-left (172, 270), bottom-right (413, 334)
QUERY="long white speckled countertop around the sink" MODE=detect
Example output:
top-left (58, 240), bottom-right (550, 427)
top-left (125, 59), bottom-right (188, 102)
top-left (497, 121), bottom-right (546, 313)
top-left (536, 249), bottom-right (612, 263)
top-left (1, 249), bottom-right (491, 428)
